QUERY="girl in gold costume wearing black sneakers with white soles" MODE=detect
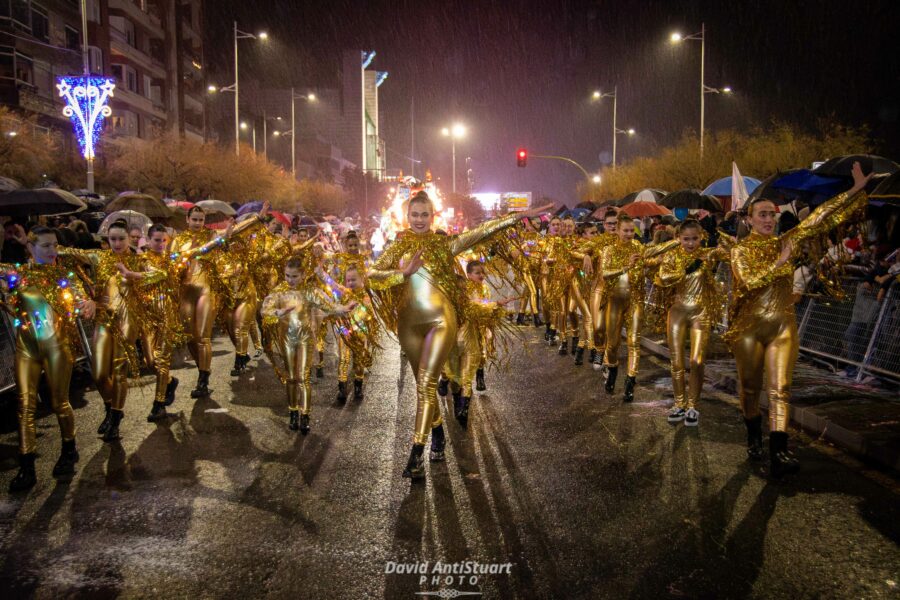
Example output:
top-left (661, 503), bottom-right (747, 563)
top-left (655, 219), bottom-right (728, 426)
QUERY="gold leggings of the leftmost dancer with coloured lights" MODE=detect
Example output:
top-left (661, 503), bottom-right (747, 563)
top-left (16, 334), bottom-right (75, 454)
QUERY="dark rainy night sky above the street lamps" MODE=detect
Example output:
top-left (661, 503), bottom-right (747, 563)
top-left (206, 0), bottom-right (900, 204)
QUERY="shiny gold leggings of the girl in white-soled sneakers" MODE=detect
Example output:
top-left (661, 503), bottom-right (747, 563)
top-left (666, 302), bottom-right (709, 410)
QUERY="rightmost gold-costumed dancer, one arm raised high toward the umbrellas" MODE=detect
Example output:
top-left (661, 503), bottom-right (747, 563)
top-left (725, 163), bottom-right (872, 477)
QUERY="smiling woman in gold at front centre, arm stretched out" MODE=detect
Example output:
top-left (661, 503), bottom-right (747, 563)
top-left (369, 192), bottom-right (549, 480)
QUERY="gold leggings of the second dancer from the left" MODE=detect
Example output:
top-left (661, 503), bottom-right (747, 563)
top-left (91, 316), bottom-right (137, 410)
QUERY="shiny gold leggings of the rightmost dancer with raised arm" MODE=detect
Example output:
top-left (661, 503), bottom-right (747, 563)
top-left (731, 312), bottom-right (800, 431)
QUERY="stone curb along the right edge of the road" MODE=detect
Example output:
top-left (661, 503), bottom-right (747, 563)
top-left (641, 336), bottom-right (900, 471)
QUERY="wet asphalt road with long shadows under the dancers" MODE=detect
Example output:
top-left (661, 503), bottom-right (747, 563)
top-left (0, 329), bottom-right (900, 599)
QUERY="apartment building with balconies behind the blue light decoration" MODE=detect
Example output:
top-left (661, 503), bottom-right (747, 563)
top-left (0, 0), bottom-right (206, 140)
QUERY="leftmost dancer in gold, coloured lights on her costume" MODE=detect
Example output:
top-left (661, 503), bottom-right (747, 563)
top-left (0, 227), bottom-right (96, 492)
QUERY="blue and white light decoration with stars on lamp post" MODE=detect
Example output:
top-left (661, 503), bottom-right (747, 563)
top-left (56, 75), bottom-right (116, 160)
